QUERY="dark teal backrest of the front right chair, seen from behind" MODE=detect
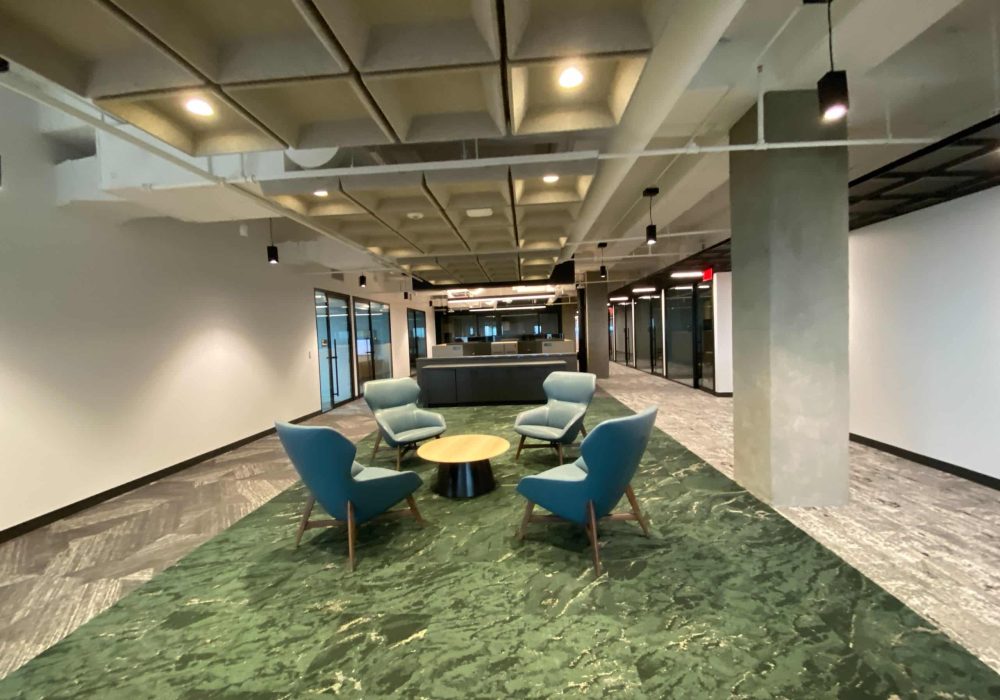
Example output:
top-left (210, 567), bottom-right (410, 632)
top-left (580, 406), bottom-right (657, 518)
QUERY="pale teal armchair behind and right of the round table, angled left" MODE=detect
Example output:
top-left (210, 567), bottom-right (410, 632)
top-left (514, 372), bottom-right (597, 464)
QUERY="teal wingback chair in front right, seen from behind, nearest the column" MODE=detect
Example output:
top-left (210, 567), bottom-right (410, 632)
top-left (517, 406), bottom-right (656, 576)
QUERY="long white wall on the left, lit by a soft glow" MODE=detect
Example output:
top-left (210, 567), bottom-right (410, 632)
top-left (0, 91), bottom-right (433, 529)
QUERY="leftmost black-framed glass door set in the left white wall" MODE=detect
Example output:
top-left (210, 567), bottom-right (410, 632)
top-left (314, 289), bottom-right (354, 411)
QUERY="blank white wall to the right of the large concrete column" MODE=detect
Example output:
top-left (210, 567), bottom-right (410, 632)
top-left (850, 188), bottom-right (1000, 478)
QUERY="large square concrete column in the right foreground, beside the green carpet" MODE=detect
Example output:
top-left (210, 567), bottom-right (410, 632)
top-left (729, 90), bottom-right (849, 506)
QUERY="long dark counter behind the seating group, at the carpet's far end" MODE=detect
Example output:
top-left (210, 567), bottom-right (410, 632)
top-left (417, 353), bottom-right (576, 406)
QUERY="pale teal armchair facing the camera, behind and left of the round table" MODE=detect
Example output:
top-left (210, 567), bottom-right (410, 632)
top-left (364, 377), bottom-right (448, 469)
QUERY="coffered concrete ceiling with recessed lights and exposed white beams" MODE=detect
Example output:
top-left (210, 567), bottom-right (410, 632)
top-left (0, 0), bottom-right (1000, 283)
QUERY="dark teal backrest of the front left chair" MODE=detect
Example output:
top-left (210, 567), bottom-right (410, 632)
top-left (274, 423), bottom-right (357, 520)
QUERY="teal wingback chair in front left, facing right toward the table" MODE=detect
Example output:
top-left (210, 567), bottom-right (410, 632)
top-left (274, 423), bottom-right (424, 571)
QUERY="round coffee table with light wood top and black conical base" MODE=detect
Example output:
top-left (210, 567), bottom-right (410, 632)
top-left (417, 435), bottom-right (510, 498)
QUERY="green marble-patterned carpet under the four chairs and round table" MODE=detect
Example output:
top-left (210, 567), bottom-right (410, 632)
top-left (0, 396), bottom-right (1000, 700)
